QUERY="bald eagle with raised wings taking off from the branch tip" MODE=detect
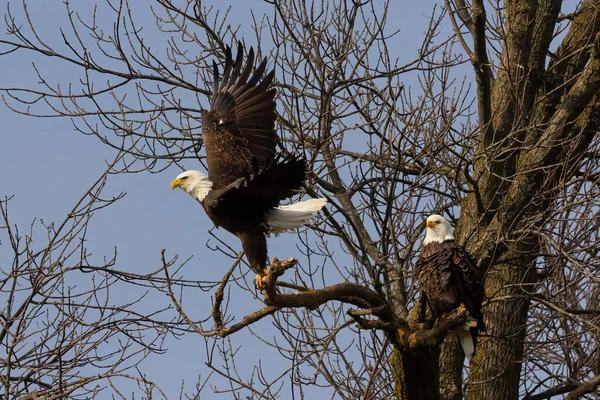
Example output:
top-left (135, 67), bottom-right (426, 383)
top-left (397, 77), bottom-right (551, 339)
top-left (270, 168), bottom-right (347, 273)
top-left (171, 44), bottom-right (327, 289)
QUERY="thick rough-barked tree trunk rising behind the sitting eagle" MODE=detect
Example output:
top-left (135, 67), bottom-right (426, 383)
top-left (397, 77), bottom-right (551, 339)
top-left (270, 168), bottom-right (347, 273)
top-left (450, 0), bottom-right (600, 400)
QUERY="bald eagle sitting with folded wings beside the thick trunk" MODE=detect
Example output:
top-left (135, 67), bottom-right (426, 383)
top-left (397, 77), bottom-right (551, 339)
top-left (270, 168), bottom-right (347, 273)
top-left (415, 214), bottom-right (485, 360)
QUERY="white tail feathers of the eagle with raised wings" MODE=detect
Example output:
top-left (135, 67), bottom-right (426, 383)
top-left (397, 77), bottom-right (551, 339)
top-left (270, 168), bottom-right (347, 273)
top-left (267, 198), bottom-right (327, 235)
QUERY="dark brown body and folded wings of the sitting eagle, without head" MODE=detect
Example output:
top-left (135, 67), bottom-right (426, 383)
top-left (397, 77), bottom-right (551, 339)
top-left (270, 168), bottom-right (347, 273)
top-left (415, 241), bottom-right (485, 330)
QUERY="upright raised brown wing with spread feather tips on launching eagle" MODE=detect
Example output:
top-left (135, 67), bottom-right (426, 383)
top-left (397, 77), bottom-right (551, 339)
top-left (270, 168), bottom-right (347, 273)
top-left (202, 44), bottom-right (276, 189)
